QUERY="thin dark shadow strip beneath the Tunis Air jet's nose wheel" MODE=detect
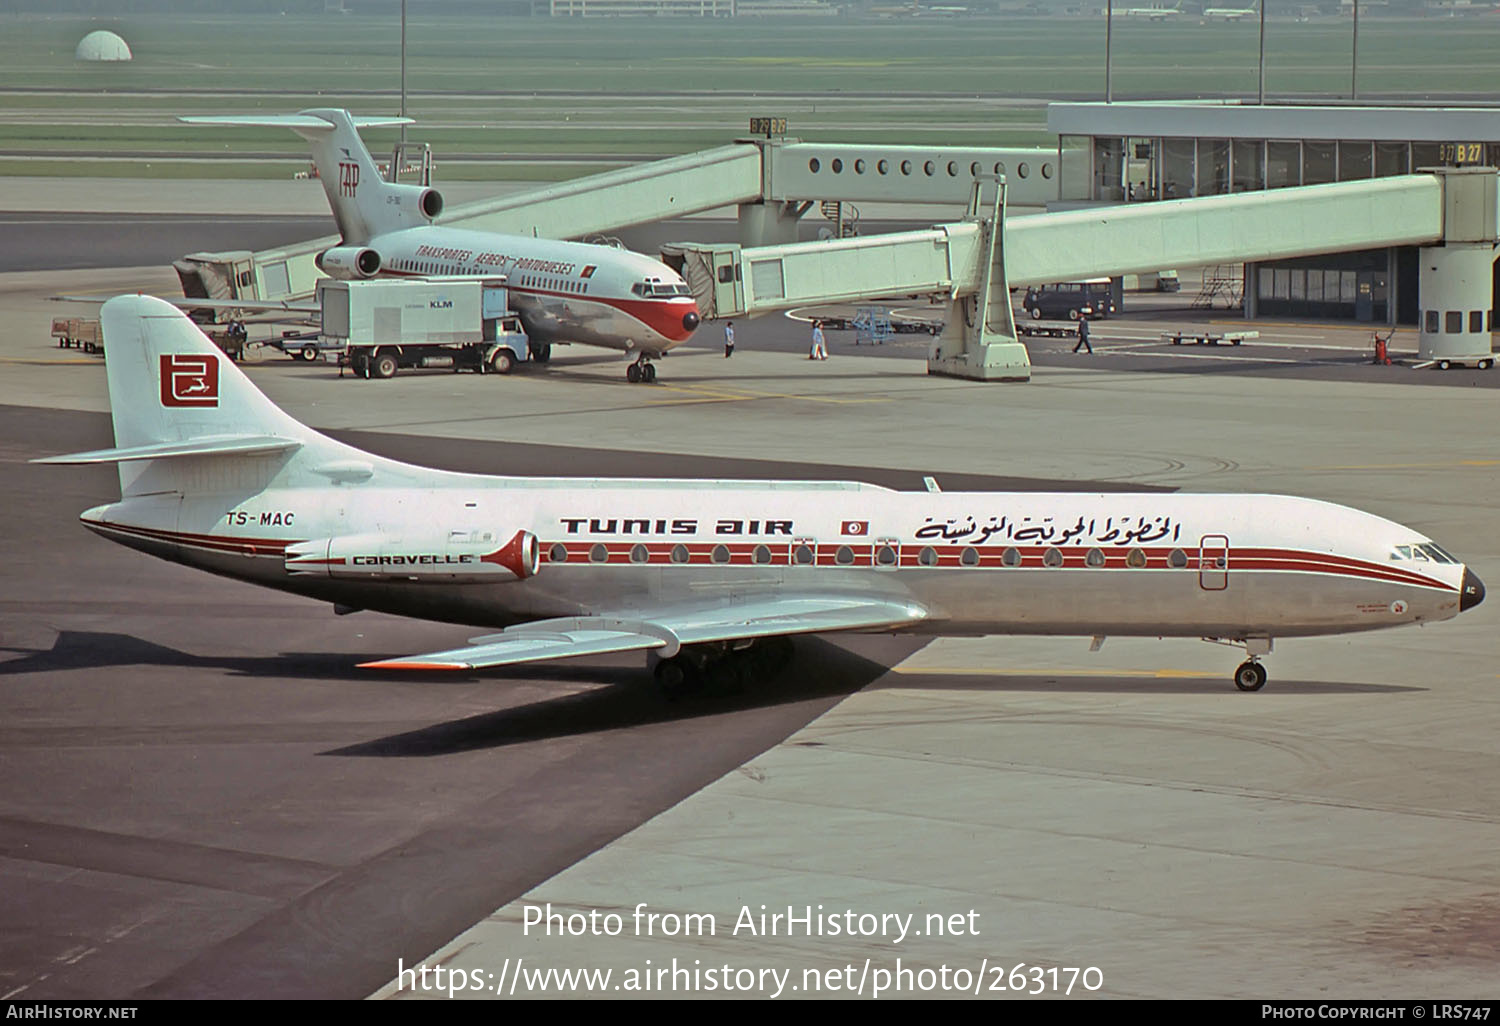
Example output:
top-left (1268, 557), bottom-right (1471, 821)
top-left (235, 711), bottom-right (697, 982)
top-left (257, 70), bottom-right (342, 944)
top-left (875, 671), bottom-right (1428, 702)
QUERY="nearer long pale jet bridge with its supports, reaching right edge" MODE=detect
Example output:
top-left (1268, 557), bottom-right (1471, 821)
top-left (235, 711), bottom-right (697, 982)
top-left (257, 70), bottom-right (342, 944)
top-left (663, 168), bottom-right (1500, 378)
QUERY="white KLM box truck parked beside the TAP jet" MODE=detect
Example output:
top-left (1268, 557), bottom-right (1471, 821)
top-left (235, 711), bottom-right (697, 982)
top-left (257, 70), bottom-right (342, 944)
top-left (318, 276), bottom-right (533, 378)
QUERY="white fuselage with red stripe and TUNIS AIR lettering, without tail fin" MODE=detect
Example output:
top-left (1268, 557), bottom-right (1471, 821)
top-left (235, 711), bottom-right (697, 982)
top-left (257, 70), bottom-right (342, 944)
top-left (83, 474), bottom-right (1464, 638)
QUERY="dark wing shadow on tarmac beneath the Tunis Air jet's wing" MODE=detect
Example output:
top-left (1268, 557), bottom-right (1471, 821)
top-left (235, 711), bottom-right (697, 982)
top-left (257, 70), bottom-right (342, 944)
top-left (323, 638), bottom-right (927, 758)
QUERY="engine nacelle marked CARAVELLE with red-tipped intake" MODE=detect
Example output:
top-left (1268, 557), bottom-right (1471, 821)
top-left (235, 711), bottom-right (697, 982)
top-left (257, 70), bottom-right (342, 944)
top-left (285, 531), bottom-right (540, 584)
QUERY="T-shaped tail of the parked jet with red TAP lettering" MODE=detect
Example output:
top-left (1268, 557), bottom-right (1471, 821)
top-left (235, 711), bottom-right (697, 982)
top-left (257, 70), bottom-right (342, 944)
top-left (179, 108), bottom-right (443, 246)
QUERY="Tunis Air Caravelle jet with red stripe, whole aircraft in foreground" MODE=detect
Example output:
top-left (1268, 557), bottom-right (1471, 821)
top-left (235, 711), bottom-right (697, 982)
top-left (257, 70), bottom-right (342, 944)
top-left (39, 296), bottom-right (1485, 692)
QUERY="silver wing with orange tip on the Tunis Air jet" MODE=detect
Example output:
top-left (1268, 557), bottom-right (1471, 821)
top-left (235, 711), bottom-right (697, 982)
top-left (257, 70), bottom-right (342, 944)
top-left (360, 594), bottom-right (927, 671)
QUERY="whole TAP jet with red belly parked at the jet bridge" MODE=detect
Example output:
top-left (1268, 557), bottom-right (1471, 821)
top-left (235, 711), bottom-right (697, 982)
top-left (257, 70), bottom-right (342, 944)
top-left (180, 110), bottom-right (702, 383)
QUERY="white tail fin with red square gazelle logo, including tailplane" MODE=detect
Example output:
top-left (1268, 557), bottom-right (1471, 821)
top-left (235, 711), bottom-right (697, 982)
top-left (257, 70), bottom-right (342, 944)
top-left (38, 296), bottom-right (357, 495)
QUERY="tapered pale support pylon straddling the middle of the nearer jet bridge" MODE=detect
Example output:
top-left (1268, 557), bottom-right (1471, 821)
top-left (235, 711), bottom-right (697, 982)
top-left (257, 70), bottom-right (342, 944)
top-left (927, 177), bottom-right (1031, 381)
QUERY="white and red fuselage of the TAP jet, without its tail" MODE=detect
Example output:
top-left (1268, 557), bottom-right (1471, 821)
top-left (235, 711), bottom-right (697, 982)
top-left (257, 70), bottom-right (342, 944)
top-left (369, 225), bottom-right (699, 356)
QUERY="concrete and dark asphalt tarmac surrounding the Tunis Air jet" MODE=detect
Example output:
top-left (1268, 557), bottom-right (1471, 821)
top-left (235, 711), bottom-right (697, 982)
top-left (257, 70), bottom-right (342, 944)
top-left (0, 180), bottom-right (1500, 999)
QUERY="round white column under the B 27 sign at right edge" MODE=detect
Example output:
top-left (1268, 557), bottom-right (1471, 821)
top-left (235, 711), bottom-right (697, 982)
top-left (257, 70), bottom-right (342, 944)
top-left (1418, 168), bottom-right (1500, 365)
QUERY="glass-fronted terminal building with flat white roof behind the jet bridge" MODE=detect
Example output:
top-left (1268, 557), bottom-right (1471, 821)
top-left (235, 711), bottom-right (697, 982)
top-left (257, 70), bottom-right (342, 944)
top-left (1047, 101), bottom-right (1500, 329)
